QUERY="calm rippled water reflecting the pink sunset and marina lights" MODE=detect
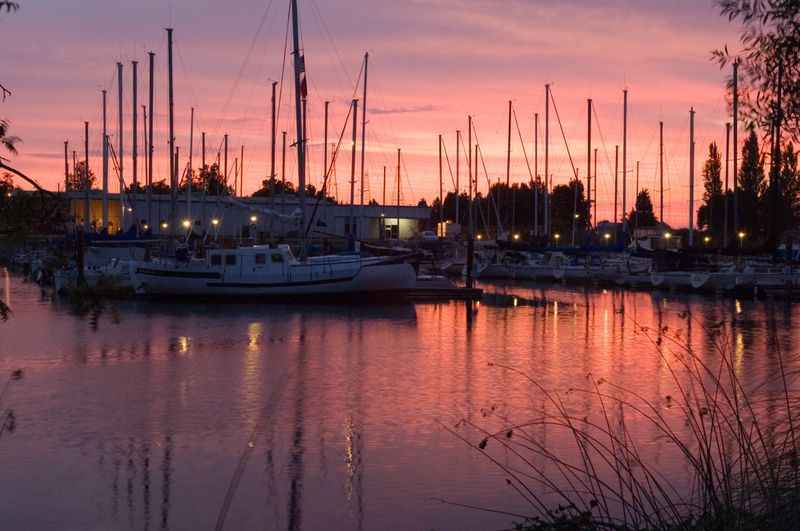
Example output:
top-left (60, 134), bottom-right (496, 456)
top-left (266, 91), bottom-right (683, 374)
top-left (0, 269), bottom-right (800, 530)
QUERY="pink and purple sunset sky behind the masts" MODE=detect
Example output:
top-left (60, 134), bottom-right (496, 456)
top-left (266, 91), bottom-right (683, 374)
top-left (0, 0), bottom-right (738, 226)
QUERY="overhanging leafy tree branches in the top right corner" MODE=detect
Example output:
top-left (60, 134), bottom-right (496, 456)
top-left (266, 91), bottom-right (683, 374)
top-left (712, 0), bottom-right (800, 140)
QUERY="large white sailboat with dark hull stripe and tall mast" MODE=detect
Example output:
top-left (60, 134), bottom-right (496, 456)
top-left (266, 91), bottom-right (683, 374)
top-left (131, 0), bottom-right (416, 298)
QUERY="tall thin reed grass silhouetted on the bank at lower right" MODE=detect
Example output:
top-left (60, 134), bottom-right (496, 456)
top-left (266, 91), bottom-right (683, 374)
top-left (447, 316), bottom-right (800, 531)
